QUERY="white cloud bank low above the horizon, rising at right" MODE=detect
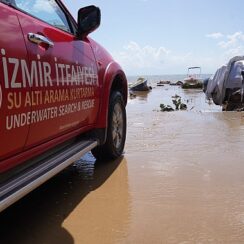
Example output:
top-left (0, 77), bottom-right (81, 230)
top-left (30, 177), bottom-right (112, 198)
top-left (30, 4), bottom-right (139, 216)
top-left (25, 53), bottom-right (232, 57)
top-left (112, 31), bottom-right (244, 75)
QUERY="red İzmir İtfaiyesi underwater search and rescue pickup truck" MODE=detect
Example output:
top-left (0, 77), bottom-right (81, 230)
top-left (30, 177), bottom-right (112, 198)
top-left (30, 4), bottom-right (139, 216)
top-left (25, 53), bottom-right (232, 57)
top-left (0, 0), bottom-right (128, 211)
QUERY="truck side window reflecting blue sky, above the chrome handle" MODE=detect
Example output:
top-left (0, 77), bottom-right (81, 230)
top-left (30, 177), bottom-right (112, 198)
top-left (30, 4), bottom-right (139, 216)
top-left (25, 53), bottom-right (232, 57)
top-left (15, 0), bottom-right (71, 32)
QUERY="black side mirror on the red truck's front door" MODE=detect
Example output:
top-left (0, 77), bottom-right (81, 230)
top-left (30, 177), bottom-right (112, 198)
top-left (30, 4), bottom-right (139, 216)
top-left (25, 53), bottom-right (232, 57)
top-left (77, 5), bottom-right (101, 38)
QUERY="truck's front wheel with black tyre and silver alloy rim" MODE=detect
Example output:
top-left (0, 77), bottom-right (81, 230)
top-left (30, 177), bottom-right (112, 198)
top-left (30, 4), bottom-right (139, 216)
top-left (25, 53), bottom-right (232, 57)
top-left (92, 92), bottom-right (126, 160)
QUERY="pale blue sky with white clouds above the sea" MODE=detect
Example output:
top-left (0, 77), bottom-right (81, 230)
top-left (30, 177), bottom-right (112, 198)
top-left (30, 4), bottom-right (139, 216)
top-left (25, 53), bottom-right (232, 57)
top-left (63, 0), bottom-right (244, 75)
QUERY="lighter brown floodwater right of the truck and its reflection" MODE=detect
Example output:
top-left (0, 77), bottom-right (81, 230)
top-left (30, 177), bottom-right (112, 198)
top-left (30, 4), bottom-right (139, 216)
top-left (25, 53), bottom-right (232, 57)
top-left (124, 87), bottom-right (244, 243)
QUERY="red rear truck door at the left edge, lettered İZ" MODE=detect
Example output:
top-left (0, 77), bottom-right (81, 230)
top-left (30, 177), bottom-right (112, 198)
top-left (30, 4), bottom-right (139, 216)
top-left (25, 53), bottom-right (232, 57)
top-left (0, 2), bottom-right (30, 160)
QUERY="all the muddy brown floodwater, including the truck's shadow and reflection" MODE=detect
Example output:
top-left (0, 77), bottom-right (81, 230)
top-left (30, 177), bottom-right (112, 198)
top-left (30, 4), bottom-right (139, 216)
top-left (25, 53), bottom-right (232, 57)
top-left (0, 86), bottom-right (244, 243)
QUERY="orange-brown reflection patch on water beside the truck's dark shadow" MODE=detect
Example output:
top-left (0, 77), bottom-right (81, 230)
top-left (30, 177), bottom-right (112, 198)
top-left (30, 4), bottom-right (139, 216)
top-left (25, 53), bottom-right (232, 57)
top-left (63, 155), bottom-right (130, 243)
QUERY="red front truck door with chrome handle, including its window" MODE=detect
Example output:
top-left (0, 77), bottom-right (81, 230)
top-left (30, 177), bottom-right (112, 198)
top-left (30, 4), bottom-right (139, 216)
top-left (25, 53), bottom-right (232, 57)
top-left (15, 0), bottom-right (100, 147)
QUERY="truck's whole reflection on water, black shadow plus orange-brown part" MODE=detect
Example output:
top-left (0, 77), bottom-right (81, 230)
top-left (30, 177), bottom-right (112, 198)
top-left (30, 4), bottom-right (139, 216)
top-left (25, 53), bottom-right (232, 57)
top-left (0, 154), bottom-right (130, 244)
